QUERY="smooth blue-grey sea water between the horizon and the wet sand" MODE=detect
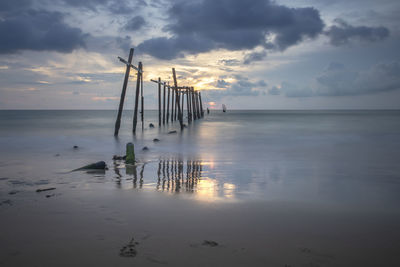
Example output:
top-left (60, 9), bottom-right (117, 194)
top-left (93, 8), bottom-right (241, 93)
top-left (0, 110), bottom-right (400, 210)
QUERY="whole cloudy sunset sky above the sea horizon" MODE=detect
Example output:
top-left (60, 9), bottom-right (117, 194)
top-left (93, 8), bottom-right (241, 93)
top-left (0, 0), bottom-right (400, 109)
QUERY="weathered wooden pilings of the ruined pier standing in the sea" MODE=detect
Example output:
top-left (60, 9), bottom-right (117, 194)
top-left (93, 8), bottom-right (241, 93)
top-left (114, 48), bottom-right (204, 136)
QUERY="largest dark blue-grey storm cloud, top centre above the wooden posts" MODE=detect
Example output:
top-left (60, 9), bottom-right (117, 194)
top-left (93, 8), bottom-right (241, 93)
top-left (138, 0), bottom-right (324, 59)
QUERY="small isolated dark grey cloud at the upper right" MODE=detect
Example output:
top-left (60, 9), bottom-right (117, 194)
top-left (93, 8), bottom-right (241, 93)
top-left (325, 19), bottom-right (389, 46)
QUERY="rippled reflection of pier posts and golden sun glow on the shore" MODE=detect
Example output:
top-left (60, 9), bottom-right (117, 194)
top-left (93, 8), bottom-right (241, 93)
top-left (114, 158), bottom-right (236, 201)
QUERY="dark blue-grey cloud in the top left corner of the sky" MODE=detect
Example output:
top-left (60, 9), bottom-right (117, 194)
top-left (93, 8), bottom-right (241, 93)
top-left (0, 1), bottom-right (87, 54)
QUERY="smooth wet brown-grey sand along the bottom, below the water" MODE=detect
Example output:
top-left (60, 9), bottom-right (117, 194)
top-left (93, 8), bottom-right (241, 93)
top-left (0, 179), bottom-right (400, 266)
